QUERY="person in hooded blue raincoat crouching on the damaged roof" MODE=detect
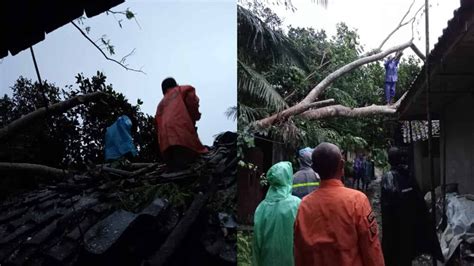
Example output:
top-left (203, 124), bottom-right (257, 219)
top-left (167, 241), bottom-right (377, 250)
top-left (105, 115), bottom-right (137, 161)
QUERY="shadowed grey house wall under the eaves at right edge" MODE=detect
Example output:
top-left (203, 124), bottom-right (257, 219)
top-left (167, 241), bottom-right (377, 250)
top-left (440, 95), bottom-right (474, 194)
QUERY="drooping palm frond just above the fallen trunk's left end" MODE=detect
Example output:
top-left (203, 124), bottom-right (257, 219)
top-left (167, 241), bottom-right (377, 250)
top-left (237, 60), bottom-right (288, 111)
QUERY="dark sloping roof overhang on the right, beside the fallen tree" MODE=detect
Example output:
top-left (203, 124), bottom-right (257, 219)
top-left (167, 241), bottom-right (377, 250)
top-left (398, 0), bottom-right (474, 120)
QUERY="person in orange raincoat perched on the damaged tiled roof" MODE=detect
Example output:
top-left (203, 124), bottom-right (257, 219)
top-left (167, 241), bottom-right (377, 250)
top-left (155, 78), bottom-right (208, 169)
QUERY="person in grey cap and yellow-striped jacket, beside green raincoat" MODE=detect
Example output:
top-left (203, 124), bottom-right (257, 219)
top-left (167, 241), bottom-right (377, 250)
top-left (292, 147), bottom-right (320, 199)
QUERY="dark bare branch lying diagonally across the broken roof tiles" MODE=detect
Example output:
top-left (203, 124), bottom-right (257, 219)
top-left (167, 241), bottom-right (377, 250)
top-left (148, 177), bottom-right (216, 266)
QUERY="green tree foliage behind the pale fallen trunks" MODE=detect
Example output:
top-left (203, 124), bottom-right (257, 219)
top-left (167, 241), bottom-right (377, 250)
top-left (238, 6), bottom-right (419, 165)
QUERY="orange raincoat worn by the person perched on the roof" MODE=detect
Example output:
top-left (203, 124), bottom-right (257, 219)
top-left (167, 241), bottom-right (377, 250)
top-left (155, 86), bottom-right (207, 153)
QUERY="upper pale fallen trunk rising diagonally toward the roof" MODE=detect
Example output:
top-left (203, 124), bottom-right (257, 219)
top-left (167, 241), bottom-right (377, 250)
top-left (256, 40), bottom-right (412, 128)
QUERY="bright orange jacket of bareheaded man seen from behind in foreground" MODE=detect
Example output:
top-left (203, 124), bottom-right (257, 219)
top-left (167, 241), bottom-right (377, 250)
top-left (294, 179), bottom-right (384, 266)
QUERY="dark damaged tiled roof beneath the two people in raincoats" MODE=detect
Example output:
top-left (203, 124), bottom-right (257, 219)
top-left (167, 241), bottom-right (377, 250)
top-left (0, 132), bottom-right (237, 265)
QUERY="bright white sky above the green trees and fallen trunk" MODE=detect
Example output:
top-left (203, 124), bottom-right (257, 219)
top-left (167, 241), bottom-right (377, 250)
top-left (273, 0), bottom-right (460, 57)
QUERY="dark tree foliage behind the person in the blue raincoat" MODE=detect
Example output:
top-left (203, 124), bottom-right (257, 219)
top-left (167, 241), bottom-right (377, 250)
top-left (0, 72), bottom-right (158, 168)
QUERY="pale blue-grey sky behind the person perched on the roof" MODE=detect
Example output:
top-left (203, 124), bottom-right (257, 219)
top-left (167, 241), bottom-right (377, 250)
top-left (0, 0), bottom-right (237, 145)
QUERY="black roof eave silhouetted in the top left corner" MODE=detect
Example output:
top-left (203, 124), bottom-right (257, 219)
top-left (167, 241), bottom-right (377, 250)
top-left (0, 0), bottom-right (124, 59)
